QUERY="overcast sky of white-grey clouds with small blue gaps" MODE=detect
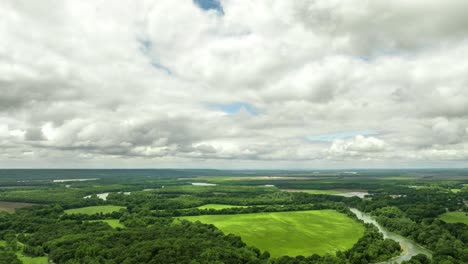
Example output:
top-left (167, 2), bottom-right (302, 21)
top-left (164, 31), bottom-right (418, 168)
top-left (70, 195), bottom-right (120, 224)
top-left (0, 0), bottom-right (468, 169)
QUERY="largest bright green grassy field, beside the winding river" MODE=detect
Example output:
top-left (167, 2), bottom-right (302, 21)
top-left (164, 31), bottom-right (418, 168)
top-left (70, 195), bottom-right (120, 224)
top-left (181, 210), bottom-right (364, 257)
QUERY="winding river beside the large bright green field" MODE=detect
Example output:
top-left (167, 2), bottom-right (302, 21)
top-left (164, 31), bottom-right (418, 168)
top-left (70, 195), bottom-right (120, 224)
top-left (350, 208), bottom-right (432, 263)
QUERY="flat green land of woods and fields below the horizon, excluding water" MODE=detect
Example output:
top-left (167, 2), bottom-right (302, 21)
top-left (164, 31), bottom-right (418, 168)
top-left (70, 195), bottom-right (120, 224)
top-left (0, 169), bottom-right (468, 264)
